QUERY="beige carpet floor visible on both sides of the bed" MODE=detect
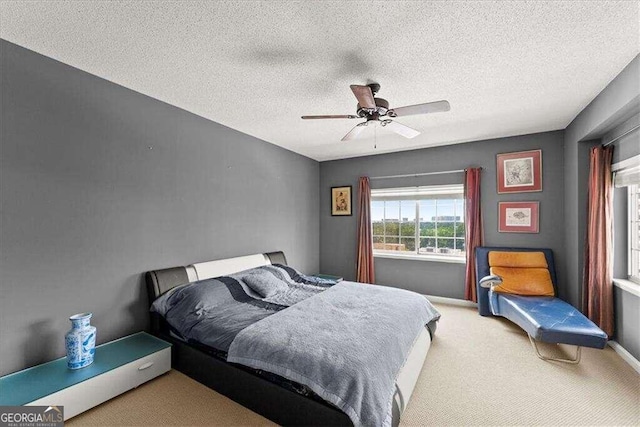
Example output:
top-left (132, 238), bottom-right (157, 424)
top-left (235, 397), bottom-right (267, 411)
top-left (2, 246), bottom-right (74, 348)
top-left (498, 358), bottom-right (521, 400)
top-left (67, 304), bottom-right (640, 427)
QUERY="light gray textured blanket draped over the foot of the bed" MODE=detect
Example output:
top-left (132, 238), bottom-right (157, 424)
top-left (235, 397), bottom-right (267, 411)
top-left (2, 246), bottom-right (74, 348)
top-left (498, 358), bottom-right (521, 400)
top-left (227, 282), bottom-right (440, 426)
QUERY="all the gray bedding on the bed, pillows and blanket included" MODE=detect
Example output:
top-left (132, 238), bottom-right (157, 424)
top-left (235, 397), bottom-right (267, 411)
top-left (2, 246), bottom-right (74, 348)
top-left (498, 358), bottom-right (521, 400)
top-left (152, 265), bottom-right (440, 426)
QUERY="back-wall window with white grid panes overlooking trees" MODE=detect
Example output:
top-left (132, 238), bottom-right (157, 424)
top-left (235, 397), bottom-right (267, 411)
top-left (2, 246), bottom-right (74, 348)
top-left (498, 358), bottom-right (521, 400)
top-left (371, 184), bottom-right (465, 260)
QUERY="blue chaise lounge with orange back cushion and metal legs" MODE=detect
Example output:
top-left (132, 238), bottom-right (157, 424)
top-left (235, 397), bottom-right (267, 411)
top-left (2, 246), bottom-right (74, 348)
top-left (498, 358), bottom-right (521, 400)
top-left (476, 247), bottom-right (608, 364)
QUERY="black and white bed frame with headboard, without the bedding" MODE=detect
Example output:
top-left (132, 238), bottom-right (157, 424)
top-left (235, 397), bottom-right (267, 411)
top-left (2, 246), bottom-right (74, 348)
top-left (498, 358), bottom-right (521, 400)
top-left (146, 252), bottom-right (431, 426)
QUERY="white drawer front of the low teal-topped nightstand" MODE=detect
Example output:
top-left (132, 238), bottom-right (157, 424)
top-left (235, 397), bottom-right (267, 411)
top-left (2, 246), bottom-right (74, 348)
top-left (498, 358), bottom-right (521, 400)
top-left (27, 348), bottom-right (171, 420)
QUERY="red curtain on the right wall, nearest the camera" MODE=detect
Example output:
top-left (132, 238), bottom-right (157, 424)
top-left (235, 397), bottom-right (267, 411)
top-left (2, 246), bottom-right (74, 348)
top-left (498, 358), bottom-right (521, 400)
top-left (582, 146), bottom-right (614, 336)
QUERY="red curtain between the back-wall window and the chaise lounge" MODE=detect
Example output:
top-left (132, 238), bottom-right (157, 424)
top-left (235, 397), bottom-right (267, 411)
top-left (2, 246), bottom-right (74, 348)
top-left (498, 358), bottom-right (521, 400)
top-left (464, 168), bottom-right (484, 302)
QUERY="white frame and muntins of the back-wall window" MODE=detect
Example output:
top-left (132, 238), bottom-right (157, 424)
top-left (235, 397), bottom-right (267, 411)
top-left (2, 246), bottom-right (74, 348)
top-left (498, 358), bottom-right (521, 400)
top-left (371, 184), bottom-right (466, 264)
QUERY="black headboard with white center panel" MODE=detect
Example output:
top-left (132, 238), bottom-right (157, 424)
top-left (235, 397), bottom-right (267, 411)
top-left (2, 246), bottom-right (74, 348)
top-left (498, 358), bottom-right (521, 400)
top-left (146, 252), bottom-right (287, 304)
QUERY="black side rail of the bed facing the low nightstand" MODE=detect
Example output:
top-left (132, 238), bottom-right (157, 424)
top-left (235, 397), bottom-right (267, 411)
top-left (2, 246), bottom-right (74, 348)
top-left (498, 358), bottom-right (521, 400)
top-left (154, 332), bottom-right (353, 426)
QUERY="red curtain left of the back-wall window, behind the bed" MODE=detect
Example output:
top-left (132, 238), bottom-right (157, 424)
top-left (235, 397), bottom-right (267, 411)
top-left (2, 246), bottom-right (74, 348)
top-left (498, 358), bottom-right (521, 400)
top-left (356, 176), bottom-right (376, 283)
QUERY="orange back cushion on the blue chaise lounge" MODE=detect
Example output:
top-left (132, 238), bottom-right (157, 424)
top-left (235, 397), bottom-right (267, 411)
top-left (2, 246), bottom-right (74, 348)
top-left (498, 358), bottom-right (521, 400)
top-left (489, 251), bottom-right (555, 296)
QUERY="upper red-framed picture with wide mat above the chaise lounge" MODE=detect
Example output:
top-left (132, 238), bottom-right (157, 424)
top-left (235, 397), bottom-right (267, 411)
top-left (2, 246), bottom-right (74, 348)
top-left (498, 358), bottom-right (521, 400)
top-left (497, 150), bottom-right (542, 194)
